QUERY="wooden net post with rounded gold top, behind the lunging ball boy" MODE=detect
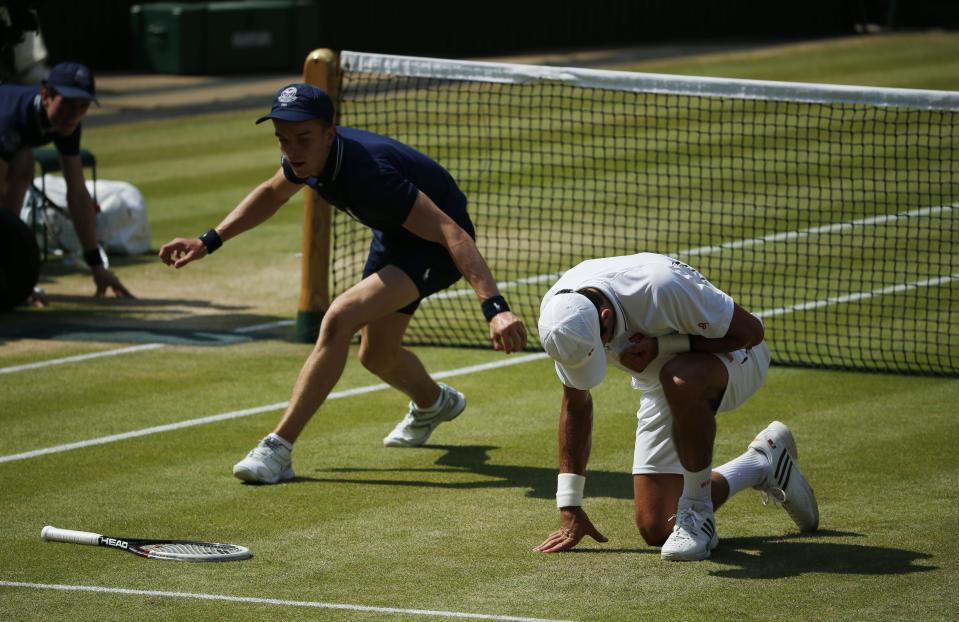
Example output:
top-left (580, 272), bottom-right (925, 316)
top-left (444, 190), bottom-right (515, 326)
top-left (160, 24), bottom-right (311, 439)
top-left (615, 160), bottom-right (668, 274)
top-left (295, 48), bottom-right (338, 343)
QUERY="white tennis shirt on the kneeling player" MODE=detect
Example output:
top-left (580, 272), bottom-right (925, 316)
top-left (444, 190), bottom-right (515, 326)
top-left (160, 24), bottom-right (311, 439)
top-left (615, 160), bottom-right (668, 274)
top-left (540, 253), bottom-right (733, 390)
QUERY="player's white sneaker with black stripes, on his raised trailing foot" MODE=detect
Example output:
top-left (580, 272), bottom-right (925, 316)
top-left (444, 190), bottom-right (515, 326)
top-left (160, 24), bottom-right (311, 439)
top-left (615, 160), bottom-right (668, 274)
top-left (749, 421), bottom-right (819, 531)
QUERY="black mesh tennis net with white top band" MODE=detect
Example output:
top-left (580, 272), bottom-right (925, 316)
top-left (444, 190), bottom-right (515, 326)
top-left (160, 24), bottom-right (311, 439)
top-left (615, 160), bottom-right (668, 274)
top-left (331, 53), bottom-right (959, 376)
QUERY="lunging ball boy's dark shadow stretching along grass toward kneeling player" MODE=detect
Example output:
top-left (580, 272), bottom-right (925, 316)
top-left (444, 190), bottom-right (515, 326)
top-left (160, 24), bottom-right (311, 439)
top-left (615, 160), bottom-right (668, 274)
top-left (292, 445), bottom-right (633, 499)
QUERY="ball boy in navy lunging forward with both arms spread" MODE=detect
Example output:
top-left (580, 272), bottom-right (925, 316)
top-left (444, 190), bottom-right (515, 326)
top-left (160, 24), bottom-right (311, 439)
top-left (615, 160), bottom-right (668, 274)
top-left (160, 84), bottom-right (526, 484)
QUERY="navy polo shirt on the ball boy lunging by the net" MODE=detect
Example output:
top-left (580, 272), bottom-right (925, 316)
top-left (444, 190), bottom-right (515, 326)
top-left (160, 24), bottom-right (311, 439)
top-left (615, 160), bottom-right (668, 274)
top-left (280, 126), bottom-right (474, 250)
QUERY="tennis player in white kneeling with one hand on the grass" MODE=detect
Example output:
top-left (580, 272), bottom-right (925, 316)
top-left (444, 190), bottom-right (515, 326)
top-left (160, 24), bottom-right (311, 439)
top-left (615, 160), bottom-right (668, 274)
top-left (536, 253), bottom-right (819, 561)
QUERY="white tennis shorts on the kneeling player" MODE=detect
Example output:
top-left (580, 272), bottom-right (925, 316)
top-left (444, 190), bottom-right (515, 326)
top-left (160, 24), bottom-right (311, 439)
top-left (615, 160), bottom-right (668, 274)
top-left (633, 341), bottom-right (770, 475)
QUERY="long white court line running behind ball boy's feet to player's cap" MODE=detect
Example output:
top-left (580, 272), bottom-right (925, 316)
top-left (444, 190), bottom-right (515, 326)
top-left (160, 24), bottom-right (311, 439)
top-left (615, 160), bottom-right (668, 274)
top-left (0, 352), bottom-right (546, 463)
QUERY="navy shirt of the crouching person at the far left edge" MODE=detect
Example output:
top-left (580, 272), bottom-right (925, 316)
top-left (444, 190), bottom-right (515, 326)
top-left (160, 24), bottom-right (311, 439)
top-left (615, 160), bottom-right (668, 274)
top-left (0, 84), bottom-right (80, 161)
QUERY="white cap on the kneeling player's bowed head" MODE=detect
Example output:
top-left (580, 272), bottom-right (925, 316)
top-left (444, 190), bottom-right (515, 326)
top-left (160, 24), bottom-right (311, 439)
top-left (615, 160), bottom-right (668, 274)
top-left (539, 293), bottom-right (606, 390)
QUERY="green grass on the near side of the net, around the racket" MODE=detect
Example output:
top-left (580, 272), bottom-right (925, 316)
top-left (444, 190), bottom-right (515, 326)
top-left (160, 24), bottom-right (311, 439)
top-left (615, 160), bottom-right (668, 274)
top-left (0, 342), bottom-right (959, 620)
